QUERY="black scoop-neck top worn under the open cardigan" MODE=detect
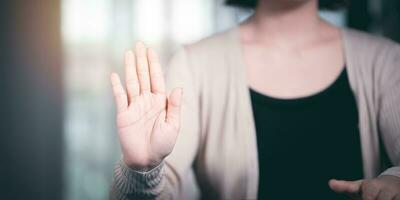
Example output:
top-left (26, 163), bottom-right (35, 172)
top-left (250, 69), bottom-right (363, 200)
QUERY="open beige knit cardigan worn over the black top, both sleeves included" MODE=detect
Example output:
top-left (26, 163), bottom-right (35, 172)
top-left (111, 28), bottom-right (400, 200)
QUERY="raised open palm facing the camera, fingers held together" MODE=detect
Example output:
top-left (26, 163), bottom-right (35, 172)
top-left (111, 42), bottom-right (182, 171)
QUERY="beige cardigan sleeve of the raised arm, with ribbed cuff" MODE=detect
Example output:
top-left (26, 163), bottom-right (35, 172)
top-left (110, 48), bottom-right (200, 200)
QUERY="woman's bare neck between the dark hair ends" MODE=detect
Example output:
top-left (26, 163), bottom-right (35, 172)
top-left (245, 0), bottom-right (322, 43)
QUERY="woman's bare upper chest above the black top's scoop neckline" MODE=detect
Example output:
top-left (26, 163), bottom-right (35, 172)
top-left (243, 40), bottom-right (345, 98)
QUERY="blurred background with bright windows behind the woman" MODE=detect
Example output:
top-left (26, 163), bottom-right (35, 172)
top-left (0, 0), bottom-right (400, 200)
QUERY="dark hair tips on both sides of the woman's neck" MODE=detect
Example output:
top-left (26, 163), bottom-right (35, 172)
top-left (225, 0), bottom-right (348, 10)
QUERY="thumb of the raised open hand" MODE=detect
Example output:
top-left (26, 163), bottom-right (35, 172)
top-left (166, 88), bottom-right (182, 130)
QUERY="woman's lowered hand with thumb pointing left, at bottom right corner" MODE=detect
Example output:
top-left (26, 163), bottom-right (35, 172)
top-left (329, 175), bottom-right (400, 200)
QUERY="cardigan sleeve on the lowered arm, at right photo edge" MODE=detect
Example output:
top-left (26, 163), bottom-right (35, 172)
top-left (378, 43), bottom-right (400, 177)
